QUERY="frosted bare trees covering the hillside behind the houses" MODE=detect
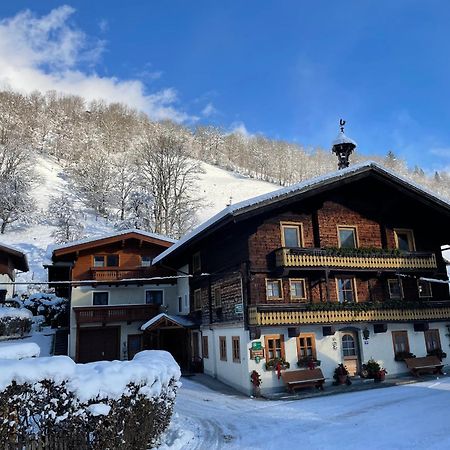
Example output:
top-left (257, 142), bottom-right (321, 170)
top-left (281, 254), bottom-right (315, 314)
top-left (0, 91), bottom-right (450, 241)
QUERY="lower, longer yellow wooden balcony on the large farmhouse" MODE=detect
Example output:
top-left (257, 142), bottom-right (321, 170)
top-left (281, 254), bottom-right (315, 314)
top-left (248, 302), bottom-right (450, 326)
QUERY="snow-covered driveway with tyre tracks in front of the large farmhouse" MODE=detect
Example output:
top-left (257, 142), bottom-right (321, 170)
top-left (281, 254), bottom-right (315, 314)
top-left (168, 378), bottom-right (450, 450)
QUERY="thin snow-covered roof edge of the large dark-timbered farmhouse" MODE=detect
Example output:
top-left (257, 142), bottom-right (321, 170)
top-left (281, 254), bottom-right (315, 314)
top-left (153, 161), bottom-right (450, 263)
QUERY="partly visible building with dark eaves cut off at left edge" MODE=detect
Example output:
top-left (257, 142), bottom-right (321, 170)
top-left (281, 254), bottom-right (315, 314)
top-left (0, 243), bottom-right (29, 302)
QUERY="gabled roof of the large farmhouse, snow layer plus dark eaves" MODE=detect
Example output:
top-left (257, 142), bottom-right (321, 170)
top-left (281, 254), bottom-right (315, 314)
top-left (153, 161), bottom-right (450, 263)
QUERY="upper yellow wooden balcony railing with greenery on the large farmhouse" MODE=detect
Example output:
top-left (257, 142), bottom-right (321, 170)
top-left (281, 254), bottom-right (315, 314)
top-left (275, 248), bottom-right (437, 270)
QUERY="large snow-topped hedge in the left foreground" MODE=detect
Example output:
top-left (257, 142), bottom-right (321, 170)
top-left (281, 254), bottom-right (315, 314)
top-left (0, 351), bottom-right (181, 450)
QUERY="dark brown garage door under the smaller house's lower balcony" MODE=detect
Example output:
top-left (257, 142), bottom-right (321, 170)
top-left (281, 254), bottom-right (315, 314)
top-left (78, 327), bottom-right (120, 363)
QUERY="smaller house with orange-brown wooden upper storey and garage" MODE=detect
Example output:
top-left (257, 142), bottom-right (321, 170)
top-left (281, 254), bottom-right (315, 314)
top-left (46, 230), bottom-right (195, 367)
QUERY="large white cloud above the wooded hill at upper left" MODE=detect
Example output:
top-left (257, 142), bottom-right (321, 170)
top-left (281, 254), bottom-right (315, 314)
top-left (0, 6), bottom-right (195, 122)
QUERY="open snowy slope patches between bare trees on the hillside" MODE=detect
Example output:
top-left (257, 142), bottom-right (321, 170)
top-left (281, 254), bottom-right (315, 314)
top-left (0, 156), bottom-right (279, 281)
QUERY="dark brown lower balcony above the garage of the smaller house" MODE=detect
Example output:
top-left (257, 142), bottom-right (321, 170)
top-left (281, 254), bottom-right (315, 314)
top-left (73, 305), bottom-right (159, 325)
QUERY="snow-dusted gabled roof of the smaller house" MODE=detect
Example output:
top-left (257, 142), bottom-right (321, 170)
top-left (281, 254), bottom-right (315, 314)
top-left (49, 229), bottom-right (177, 256)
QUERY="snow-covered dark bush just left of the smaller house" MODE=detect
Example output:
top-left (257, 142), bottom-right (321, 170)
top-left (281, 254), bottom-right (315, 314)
top-left (21, 292), bottom-right (68, 327)
